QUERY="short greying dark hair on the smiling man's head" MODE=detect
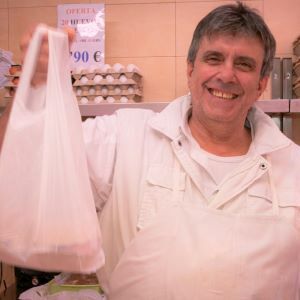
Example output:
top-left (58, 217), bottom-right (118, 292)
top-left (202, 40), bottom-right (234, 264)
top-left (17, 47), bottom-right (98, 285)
top-left (187, 1), bottom-right (276, 77)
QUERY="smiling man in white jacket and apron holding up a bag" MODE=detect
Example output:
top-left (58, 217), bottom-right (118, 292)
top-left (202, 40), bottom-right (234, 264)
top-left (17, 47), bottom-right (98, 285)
top-left (2, 2), bottom-right (300, 300)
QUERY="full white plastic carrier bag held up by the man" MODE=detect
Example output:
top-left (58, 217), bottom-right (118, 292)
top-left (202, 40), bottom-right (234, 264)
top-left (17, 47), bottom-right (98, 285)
top-left (0, 26), bottom-right (104, 273)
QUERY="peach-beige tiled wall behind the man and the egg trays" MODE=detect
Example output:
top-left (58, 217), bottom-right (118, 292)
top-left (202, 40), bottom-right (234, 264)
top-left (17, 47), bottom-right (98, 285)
top-left (0, 0), bottom-right (300, 101)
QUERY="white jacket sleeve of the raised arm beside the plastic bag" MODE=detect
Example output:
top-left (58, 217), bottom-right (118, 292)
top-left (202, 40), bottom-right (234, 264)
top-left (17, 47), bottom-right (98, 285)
top-left (83, 115), bottom-right (117, 211)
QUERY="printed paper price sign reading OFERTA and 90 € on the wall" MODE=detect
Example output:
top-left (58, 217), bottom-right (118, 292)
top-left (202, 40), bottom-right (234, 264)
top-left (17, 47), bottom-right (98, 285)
top-left (57, 4), bottom-right (105, 70)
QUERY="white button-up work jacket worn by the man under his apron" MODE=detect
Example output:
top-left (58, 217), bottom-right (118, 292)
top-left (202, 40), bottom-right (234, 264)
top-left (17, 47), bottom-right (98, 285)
top-left (83, 96), bottom-right (300, 290)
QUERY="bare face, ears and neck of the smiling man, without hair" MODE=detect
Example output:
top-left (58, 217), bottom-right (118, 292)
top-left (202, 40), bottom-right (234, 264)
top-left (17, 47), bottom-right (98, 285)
top-left (187, 33), bottom-right (268, 156)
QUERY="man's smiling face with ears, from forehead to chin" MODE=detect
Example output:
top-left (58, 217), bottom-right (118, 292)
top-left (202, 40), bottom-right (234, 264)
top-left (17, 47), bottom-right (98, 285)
top-left (187, 35), bottom-right (268, 126)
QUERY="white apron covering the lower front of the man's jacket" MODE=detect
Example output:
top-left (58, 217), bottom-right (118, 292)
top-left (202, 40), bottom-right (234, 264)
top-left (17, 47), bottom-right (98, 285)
top-left (109, 157), bottom-right (300, 300)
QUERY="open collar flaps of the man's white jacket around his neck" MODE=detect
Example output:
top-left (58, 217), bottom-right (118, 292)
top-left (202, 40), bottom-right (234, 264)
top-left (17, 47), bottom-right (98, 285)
top-left (150, 95), bottom-right (292, 155)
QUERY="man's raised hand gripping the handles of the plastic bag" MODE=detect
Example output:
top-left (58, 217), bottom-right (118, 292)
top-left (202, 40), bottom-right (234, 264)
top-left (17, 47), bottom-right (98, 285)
top-left (20, 25), bottom-right (75, 86)
